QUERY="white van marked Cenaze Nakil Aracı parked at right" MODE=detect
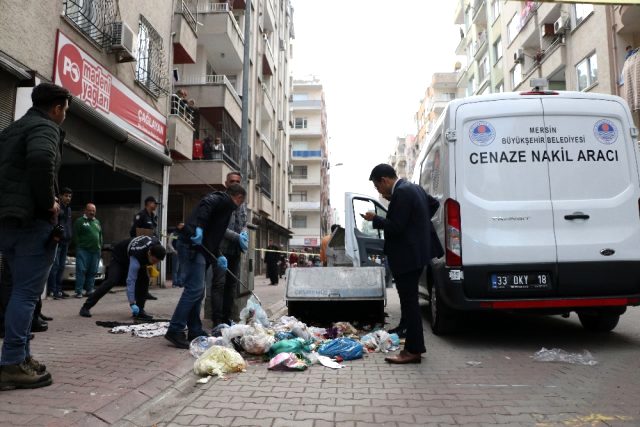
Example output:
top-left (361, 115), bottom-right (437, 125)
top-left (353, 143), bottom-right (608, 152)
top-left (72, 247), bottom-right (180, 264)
top-left (413, 91), bottom-right (640, 334)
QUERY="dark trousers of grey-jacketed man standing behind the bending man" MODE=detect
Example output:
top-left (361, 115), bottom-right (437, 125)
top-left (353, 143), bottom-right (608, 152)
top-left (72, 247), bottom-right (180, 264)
top-left (211, 254), bottom-right (240, 326)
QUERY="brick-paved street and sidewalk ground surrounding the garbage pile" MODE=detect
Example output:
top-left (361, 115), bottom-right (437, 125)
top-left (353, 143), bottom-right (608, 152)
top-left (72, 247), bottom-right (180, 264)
top-left (0, 277), bottom-right (640, 426)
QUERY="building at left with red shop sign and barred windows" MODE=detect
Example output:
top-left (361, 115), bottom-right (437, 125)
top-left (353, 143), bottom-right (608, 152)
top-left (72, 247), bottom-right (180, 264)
top-left (0, 0), bottom-right (174, 251)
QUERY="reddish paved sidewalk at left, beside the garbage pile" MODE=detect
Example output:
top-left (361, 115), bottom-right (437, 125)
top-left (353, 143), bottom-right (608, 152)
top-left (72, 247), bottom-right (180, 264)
top-left (0, 276), bottom-right (296, 426)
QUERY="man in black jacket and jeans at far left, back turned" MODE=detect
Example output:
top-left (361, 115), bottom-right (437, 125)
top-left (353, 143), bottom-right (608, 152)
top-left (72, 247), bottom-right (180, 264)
top-left (0, 83), bottom-right (71, 389)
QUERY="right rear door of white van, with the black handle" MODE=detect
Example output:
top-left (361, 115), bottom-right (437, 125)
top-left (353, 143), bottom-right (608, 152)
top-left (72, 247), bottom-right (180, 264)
top-left (542, 96), bottom-right (640, 296)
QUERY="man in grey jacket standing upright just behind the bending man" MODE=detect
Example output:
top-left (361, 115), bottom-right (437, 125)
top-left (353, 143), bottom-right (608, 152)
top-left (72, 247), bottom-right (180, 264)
top-left (211, 172), bottom-right (249, 327)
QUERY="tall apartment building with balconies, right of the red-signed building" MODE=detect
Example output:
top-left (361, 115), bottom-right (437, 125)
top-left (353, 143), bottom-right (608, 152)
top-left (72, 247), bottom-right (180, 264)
top-left (168, 0), bottom-right (294, 272)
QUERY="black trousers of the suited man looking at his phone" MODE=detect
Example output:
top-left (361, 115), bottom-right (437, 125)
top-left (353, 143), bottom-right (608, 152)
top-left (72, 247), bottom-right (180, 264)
top-left (393, 268), bottom-right (427, 353)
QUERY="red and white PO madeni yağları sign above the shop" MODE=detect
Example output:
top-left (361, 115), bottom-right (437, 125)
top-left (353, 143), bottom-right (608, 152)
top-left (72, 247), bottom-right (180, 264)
top-left (53, 31), bottom-right (167, 151)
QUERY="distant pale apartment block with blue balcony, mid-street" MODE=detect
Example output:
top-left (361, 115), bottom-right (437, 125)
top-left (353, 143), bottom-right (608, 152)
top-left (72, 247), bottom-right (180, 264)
top-left (289, 77), bottom-right (332, 252)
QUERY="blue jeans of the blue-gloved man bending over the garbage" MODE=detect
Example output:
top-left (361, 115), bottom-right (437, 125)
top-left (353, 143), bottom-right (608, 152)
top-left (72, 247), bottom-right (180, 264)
top-left (169, 246), bottom-right (207, 335)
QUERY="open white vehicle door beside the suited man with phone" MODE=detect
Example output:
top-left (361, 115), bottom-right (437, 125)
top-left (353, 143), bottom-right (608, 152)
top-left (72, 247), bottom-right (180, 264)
top-left (344, 193), bottom-right (387, 267)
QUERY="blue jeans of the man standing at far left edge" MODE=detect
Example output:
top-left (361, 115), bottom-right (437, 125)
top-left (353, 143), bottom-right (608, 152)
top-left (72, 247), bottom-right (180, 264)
top-left (0, 220), bottom-right (56, 365)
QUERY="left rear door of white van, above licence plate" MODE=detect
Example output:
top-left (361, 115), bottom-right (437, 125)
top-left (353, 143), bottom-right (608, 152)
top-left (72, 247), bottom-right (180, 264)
top-left (452, 97), bottom-right (556, 298)
